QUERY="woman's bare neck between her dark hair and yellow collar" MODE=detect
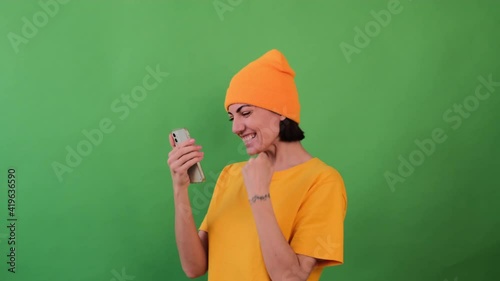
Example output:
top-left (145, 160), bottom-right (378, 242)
top-left (266, 141), bottom-right (313, 171)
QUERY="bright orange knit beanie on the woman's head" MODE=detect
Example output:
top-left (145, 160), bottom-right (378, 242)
top-left (224, 49), bottom-right (300, 123)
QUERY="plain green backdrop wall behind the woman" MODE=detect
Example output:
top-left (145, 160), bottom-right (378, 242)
top-left (0, 0), bottom-right (500, 281)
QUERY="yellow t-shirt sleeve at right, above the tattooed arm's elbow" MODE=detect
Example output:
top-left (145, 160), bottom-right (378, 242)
top-left (290, 170), bottom-right (347, 266)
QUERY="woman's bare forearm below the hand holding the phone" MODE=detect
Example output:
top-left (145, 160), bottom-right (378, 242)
top-left (174, 188), bottom-right (208, 278)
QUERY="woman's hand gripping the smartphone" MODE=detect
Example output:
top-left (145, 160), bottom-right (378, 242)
top-left (167, 134), bottom-right (203, 188)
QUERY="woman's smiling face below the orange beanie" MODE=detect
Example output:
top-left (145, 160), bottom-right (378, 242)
top-left (228, 103), bottom-right (285, 155)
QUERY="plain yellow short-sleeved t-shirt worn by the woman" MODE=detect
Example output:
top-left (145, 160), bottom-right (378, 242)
top-left (200, 158), bottom-right (347, 281)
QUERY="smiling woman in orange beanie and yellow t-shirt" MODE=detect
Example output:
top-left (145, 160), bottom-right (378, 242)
top-left (168, 50), bottom-right (347, 281)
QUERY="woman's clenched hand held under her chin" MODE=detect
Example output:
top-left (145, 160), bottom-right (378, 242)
top-left (242, 152), bottom-right (273, 199)
